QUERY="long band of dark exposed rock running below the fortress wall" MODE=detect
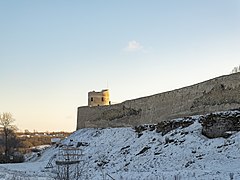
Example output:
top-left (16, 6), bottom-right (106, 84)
top-left (134, 109), bottom-right (240, 141)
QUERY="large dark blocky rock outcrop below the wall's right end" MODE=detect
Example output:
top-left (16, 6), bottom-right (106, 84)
top-left (201, 111), bottom-right (240, 138)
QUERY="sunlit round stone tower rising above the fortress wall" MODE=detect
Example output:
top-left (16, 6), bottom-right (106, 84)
top-left (88, 89), bottom-right (111, 107)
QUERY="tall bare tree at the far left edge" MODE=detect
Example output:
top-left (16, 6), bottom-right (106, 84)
top-left (0, 113), bottom-right (16, 157)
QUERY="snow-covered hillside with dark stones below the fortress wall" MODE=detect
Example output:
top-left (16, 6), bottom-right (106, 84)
top-left (0, 111), bottom-right (240, 180)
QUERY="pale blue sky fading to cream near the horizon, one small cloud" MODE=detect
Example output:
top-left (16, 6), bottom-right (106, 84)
top-left (0, 0), bottom-right (240, 131)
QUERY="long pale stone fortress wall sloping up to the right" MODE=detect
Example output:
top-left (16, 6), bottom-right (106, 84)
top-left (77, 73), bottom-right (240, 129)
